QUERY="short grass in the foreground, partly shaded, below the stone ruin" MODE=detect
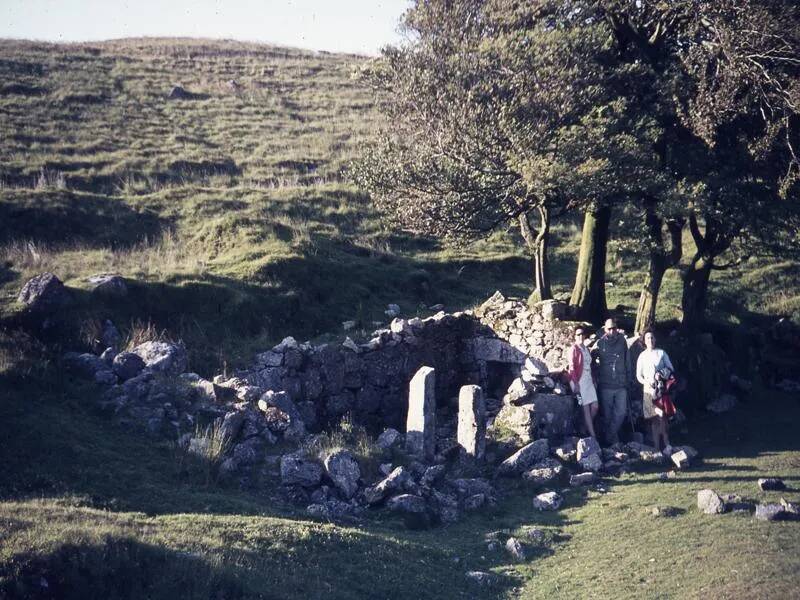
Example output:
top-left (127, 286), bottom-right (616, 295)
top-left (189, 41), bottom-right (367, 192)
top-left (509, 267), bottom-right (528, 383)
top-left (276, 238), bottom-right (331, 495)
top-left (0, 332), bottom-right (800, 598)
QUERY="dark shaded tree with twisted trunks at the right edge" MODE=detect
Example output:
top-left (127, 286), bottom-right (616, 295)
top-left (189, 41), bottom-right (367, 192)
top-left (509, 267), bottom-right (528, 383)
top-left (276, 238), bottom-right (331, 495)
top-left (594, 0), bottom-right (800, 328)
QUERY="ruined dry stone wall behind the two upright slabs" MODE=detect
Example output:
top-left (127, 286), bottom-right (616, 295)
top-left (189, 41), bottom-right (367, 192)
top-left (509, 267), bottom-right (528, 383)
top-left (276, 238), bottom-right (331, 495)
top-left (228, 292), bottom-right (574, 428)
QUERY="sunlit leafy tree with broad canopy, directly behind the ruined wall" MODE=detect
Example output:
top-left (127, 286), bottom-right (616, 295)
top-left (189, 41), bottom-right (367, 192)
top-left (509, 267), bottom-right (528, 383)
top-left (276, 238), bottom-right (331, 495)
top-left (353, 0), bottom-right (658, 308)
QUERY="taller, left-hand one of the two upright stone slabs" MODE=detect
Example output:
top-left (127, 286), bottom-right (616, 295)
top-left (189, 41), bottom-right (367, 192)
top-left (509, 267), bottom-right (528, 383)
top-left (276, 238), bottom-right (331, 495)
top-left (406, 367), bottom-right (436, 460)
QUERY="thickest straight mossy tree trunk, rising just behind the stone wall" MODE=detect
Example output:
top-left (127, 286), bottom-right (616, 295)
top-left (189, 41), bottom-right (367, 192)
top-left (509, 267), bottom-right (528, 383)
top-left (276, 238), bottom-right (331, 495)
top-left (569, 206), bottom-right (611, 322)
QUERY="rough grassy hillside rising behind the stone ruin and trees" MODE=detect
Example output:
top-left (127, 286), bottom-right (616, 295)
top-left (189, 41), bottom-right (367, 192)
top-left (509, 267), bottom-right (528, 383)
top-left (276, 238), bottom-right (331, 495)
top-left (0, 39), bottom-right (800, 372)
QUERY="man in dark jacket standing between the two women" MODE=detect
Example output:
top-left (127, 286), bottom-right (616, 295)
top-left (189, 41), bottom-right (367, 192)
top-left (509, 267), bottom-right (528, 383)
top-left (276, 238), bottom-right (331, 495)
top-left (594, 319), bottom-right (630, 445)
